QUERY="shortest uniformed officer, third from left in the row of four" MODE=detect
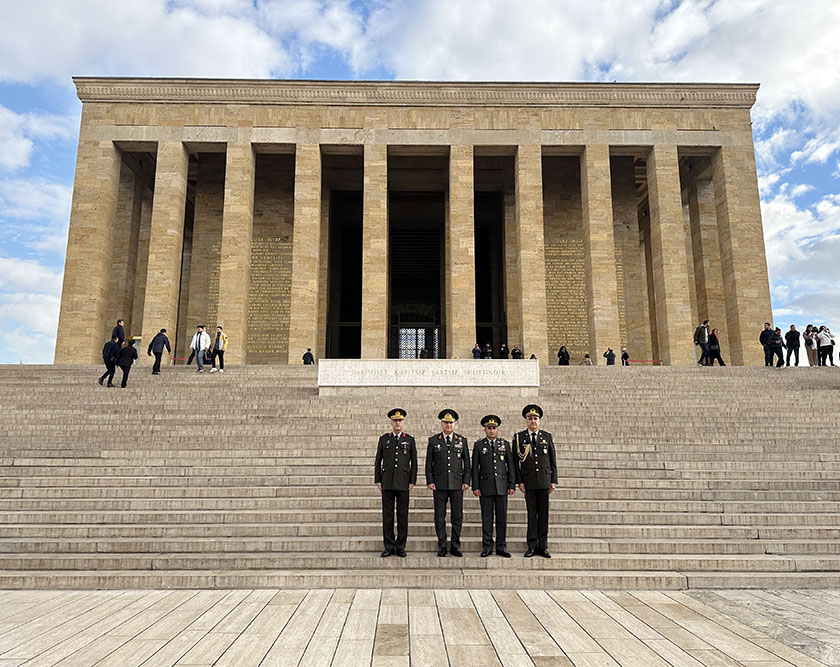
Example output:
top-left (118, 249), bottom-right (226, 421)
top-left (472, 415), bottom-right (516, 558)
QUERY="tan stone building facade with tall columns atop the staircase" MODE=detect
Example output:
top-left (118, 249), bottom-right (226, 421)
top-left (55, 78), bottom-right (771, 365)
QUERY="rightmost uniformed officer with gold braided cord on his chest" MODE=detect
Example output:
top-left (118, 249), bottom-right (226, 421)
top-left (513, 404), bottom-right (557, 558)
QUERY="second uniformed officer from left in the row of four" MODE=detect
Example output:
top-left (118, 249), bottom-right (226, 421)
top-left (426, 410), bottom-right (470, 558)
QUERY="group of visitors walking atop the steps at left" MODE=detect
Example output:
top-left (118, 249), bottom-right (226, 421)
top-left (99, 319), bottom-right (228, 387)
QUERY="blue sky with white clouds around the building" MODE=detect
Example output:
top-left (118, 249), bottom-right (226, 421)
top-left (0, 0), bottom-right (840, 363)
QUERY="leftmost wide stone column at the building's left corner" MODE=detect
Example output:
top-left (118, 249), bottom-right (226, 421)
top-left (55, 139), bottom-right (121, 364)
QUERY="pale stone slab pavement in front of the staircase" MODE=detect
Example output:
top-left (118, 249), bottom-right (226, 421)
top-left (0, 589), bottom-right (840, 667)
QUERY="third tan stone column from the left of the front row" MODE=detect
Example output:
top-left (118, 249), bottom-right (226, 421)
top-left (215, 142), bottom-right (254, 364)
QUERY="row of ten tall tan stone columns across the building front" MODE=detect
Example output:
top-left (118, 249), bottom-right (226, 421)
top-left (56, 141), bottom-right (769, 365)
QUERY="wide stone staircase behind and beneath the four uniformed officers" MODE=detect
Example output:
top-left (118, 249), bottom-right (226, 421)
top-left (0, 361), bottom-right (840, 589)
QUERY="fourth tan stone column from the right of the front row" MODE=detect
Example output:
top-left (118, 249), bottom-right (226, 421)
top-left (514, 145), bottom-right (550, 365)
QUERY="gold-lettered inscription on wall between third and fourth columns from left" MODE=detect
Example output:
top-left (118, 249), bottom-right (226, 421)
top-left (248, 236), bottom-right (292, 363)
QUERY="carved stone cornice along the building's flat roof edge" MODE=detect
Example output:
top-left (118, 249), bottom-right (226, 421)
top-left (73, 77), bottom-right (758, 109)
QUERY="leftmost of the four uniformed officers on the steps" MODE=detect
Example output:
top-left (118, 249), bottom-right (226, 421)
top-left (373, 408), bottom-right (417, 558)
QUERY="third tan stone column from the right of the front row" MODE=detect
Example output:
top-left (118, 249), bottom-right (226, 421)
top-left (580, 145), bottom-right (621, 362)
